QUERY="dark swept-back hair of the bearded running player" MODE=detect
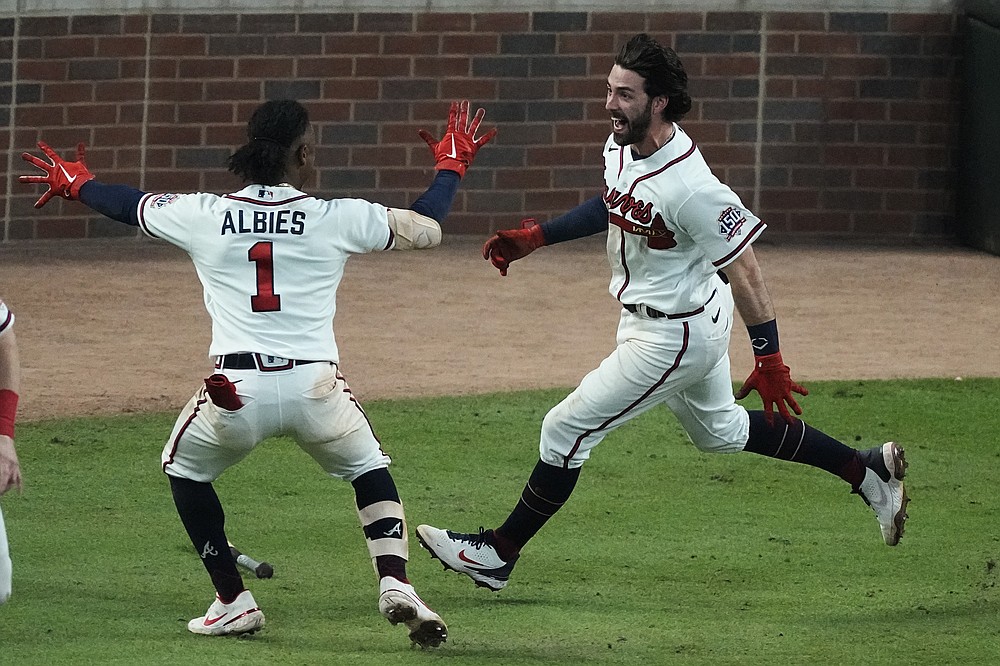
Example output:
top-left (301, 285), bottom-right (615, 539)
top-left (615, 32), bottom-right (691, 122)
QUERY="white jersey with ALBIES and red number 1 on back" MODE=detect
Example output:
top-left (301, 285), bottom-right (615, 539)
top-left (139, 185), bottom-right (393, 362)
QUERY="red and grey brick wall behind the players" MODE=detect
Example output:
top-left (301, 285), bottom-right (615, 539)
top-left (0, 12), bottom-right (958, 241)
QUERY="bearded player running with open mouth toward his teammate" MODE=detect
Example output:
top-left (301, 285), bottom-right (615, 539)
top-left (417, 34), bottom-right (908, 590)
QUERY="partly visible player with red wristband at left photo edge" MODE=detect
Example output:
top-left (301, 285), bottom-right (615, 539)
top-left (0, 300), bottom-right (22, 604)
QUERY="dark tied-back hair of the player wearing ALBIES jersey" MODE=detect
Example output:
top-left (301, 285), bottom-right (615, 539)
top-left (229, 99), bottom-right (309, 185)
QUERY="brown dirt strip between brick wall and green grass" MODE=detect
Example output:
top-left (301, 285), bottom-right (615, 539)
top-left (0, 237), bottom-right (1000, 421)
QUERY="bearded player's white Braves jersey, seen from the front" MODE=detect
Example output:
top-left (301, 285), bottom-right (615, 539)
top-left (604, 125), bottom-right (767, 317)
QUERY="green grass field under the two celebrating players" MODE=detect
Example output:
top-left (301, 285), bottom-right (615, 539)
top-left (0, 380), bottom-right (1000, 666)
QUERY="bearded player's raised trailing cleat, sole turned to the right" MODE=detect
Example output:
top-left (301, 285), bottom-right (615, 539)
top-left (856, 442), bottom-right (910, 546)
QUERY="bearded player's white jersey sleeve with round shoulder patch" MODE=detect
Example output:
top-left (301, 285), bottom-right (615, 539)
top-left (677, 181), bottom-right (767, 268)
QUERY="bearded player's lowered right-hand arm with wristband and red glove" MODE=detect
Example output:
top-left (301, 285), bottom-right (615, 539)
top-left (725, 247), bottom-right (809, 423)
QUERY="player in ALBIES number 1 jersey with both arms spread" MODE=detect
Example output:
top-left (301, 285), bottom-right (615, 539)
top-left (20, 100), bottom-right (496, 647)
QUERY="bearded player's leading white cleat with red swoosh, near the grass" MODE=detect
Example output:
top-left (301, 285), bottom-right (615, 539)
top-left (417, 525), bottom-right (517, 592)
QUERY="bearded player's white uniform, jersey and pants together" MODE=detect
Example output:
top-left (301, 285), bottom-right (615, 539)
top-left (539, 125), bottom-right (765, 467)
